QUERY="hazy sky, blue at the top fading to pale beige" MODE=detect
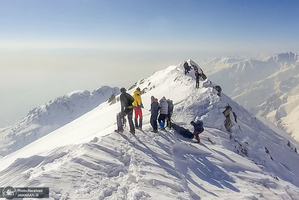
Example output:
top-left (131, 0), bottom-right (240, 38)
top-left (0, 0), bottom-right (299, 127)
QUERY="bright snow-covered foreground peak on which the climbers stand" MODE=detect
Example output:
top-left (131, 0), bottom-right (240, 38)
top-left (0, 60), bottom-right (299, 200)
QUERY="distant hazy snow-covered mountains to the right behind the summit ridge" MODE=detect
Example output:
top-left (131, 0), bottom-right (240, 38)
top-left (201, 52), bottom-right (299, 141)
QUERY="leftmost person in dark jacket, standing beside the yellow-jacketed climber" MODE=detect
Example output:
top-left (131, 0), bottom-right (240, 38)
top-left (116, 88), bottom-right (135, 134)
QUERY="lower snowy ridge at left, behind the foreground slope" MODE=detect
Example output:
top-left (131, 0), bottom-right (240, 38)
top-left (0, 86), bottom-right (120, 157)
